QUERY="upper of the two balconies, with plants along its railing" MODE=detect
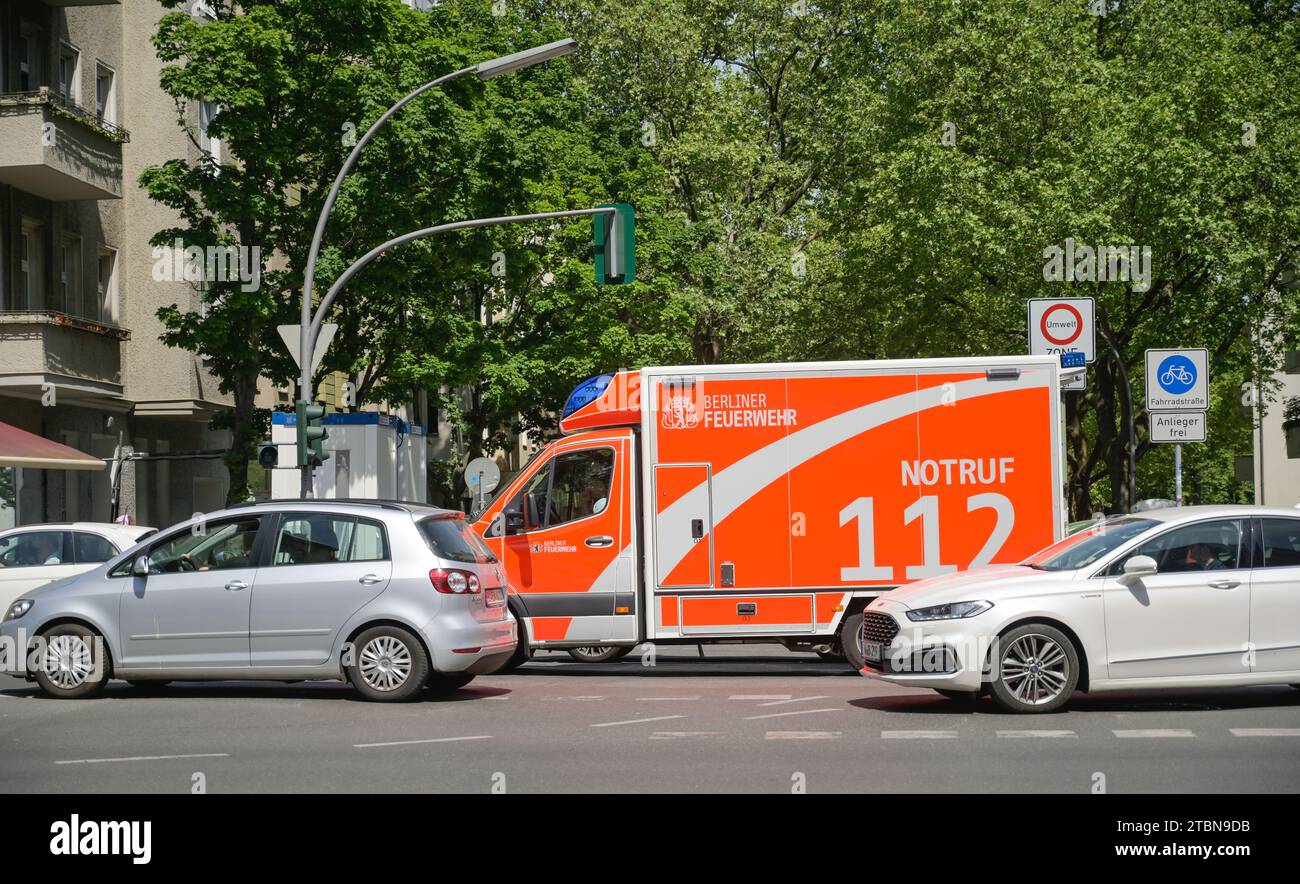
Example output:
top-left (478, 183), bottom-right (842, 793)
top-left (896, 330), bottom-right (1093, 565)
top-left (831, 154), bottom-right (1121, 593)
top-left (0, 87), bottom-right (130, 202)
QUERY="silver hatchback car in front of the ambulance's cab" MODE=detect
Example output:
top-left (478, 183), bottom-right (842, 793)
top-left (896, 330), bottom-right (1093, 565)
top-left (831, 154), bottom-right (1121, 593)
top-left (0, 501), bottom-right (517, 701)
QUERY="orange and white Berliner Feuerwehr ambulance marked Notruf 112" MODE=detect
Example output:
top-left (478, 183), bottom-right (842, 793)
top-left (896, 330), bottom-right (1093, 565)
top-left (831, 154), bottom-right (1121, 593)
top-left (475, 356), bottom-right (1065, 668)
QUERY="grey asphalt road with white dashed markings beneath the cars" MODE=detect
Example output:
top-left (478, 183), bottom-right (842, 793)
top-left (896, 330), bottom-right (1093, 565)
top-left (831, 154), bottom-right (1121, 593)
top-left (0, 645), bottom-right (1300, 793)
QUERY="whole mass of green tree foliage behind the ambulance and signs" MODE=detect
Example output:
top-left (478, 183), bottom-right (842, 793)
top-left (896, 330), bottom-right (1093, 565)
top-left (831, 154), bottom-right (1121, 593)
top-left (143, 0), bottom-right (1300, 515)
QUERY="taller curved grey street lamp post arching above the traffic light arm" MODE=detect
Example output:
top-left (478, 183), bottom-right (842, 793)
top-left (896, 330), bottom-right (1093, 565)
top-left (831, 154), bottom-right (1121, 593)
top-left (298, 38), bottom-right (577, 498)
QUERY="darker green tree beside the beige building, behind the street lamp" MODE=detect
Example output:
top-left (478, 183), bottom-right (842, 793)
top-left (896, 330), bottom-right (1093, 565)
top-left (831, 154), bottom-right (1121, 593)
top-left (140, 0), bottom-right (504, 499)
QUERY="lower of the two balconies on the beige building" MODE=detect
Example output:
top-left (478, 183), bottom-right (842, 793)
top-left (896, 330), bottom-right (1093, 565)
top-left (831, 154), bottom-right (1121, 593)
top-left (0, 311), bottom-right (130, 404)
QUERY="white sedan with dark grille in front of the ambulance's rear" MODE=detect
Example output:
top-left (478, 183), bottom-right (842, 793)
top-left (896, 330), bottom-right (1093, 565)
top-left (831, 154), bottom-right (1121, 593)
top-left (862, 506), bottom-right (1300, 712)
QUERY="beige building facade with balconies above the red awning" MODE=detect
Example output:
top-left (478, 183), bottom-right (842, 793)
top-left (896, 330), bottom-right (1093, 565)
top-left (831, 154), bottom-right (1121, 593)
top-left (0, 0), bottom-right (229, 527)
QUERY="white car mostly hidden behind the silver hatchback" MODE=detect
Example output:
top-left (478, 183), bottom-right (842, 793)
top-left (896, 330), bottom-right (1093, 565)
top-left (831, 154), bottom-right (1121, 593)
top-left (0, 521), bottom-right (153, 610)
